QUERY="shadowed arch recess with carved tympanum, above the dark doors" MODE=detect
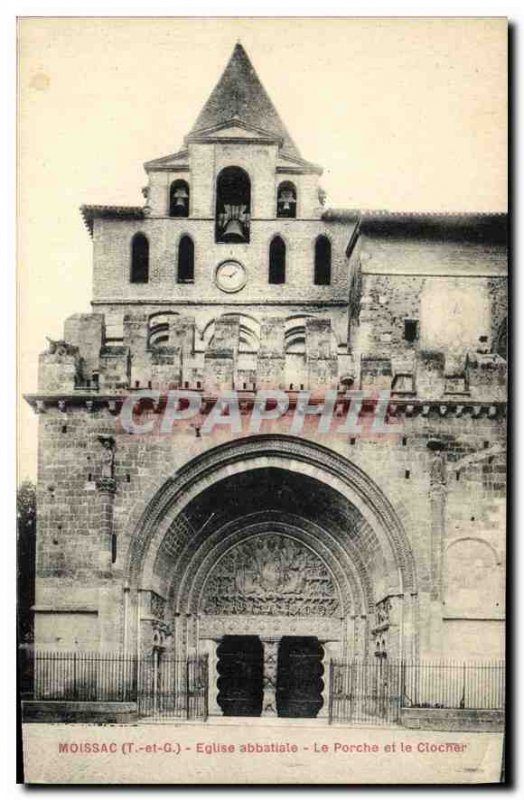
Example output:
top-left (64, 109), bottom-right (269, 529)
top-left (147, 467), bottom-right (406, 664)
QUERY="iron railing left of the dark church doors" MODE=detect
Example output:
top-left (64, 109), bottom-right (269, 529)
top-left (19, 650), bottom-right (208, 719)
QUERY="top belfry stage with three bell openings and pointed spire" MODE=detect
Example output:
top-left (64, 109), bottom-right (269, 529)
top-left (145, 43), bottom-right (322, 225)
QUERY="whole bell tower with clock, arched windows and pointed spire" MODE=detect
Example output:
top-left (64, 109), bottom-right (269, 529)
top-left (82, 43), bottom-right (357, 391)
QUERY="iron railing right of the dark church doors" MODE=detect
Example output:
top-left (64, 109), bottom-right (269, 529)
top-left (328, 659), bottom-right (505, 725)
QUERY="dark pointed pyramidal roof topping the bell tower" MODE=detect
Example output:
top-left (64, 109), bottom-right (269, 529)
top-left (188, 42), bottom-right (302, 161)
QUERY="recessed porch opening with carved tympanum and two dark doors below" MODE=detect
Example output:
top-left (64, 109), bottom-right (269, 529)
top-left (149, 467), bottom-right (404, 717)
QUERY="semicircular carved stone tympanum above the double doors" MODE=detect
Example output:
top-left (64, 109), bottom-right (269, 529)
top-left (202, 534), bottom-right (340, 616)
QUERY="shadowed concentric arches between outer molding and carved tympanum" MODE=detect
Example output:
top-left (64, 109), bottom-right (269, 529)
top-left (154, 468), bottom-right (386, 614)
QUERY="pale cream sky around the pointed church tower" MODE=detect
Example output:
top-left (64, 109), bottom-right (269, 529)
top-left (18, 17), bottom-right (507, 478)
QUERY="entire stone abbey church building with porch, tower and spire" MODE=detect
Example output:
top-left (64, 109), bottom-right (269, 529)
top-left (28, 45), bottom-right (507, 720)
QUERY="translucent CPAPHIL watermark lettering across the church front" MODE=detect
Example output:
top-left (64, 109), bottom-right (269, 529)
top-left (119, 389), bottom-right (401, 437)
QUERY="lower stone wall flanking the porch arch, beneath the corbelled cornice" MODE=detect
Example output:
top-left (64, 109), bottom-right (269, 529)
top-left (31, 401), bottom-right (505, 657)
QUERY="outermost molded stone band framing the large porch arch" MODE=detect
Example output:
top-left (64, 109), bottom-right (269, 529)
top-left (127, 435), bottom-right (416, 593)
